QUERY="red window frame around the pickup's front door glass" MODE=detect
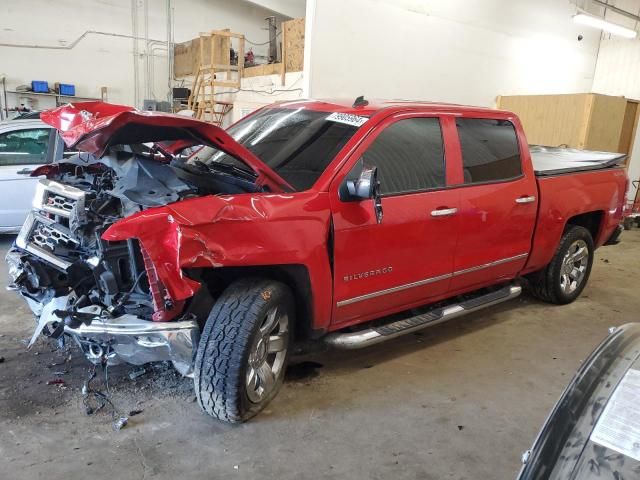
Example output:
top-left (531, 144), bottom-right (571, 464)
top-left (340, 112), bottom-right (452, 198)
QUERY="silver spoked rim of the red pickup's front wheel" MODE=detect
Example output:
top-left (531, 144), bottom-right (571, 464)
top-left (246, 306), bottom-right (289, 403)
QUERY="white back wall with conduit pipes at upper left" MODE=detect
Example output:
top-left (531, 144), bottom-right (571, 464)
top-left (0, 0), bottom-right (282, 108)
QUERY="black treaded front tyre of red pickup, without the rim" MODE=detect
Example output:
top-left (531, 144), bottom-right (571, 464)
top-left (194, 278), bottom-right (295, 423)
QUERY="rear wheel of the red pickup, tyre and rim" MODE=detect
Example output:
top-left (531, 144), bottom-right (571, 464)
top-left (528, 225), bottom-right (594, 305)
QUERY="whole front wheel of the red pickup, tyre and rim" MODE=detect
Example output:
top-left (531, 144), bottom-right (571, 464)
top-left (194, 279), bottom-right (294, 423)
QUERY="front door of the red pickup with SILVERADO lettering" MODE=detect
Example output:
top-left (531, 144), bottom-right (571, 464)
top-left (330, 113), bottom-right (458, 326)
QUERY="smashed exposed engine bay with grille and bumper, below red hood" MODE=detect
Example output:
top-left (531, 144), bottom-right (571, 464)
top-left (7, 145), bottom-right (261, 375)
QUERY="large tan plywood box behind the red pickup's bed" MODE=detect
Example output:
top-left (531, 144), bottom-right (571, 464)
top-left (497, 93), bottom-right (639, 153)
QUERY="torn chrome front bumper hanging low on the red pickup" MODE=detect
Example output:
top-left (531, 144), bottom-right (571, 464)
top-left (28, 296), bottom-right (200, 377)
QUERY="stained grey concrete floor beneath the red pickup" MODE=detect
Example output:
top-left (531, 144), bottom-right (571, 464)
top-left (0, 229), bottom-right (640, 480)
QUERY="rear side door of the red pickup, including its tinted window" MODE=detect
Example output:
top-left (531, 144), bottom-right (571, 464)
top-left (451, 117), bottom-right (538, 294)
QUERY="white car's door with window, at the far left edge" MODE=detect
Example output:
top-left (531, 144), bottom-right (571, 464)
top-left (0, 125), bottom-right (56, 232)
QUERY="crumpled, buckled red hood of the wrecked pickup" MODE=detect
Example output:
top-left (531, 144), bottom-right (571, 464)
top-left (40, 102), bottom-right (293, 192)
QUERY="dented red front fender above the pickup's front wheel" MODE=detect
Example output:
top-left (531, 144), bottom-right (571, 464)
top-left (102, 191), bottom-right (332, 328)
